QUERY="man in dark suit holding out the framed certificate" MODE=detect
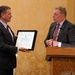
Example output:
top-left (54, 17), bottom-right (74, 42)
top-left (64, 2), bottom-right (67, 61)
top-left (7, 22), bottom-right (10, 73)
top-left (0, 6), bottom-right (27, 75)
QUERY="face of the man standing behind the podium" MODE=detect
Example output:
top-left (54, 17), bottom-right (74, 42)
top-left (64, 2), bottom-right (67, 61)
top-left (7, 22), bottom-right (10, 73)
top-left (53, 9), bottom-right (64, 23)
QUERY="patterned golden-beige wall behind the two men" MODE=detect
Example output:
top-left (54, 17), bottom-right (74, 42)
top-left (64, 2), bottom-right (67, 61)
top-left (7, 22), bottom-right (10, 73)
top-left (0, 0), bottom-right (75, 75)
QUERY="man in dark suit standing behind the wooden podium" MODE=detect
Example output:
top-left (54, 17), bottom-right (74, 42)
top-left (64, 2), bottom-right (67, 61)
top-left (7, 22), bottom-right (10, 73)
top-left (44, 6), bottom-right (75, 60)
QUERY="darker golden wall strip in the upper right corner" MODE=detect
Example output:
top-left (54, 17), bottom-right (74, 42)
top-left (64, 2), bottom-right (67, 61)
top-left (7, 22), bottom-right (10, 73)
top-left (66, 0), bottom-right (75, 23)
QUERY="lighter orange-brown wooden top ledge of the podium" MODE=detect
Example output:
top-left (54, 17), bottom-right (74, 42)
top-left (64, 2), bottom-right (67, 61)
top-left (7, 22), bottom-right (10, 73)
top-left (46, 47), bottom-right (75, 57)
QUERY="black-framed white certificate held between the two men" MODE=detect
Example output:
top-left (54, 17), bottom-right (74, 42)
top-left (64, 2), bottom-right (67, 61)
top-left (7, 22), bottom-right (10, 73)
top-left (16, 30), bottom-right (37, 50)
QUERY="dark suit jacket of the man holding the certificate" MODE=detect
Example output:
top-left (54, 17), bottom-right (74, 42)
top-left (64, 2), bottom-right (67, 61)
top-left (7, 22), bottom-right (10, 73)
top-left (0, 22), bottom-right (17, 69)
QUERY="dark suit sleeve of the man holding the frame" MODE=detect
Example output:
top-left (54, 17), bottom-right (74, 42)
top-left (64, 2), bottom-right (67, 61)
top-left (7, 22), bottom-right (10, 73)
top-left (0, 30), bottom-right (17, 54)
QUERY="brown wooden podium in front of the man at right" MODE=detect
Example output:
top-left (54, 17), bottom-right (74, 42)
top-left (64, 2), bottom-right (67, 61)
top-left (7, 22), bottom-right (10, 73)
top-left (46, 47), bottom-right (75, 75)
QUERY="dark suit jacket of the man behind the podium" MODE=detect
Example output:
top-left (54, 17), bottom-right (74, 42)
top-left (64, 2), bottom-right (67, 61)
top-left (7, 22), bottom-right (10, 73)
top-left (44, 20), bottom-right (75, 60)
